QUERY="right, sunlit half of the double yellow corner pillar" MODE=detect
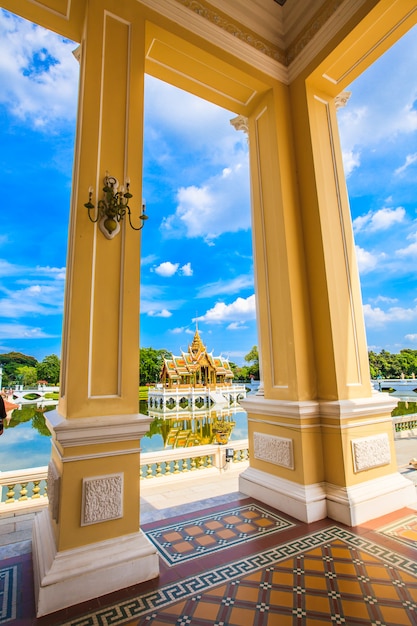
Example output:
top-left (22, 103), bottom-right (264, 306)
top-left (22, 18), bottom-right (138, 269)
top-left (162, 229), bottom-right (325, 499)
top-left (292, 80), bottom-right (415, 525)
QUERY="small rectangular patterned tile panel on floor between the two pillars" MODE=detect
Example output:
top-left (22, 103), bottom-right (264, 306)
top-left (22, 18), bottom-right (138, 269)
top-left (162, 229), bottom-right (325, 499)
top-left (145, 504), bottom-right (295, 566)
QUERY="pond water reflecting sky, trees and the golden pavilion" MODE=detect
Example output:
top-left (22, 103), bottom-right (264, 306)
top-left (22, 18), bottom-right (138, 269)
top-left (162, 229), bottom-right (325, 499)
top-left (0, 399), bottom-right (417, 472)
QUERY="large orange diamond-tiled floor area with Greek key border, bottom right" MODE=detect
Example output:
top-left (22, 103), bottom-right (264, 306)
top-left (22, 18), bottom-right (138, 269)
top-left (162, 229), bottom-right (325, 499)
top-left (63, 526), bottom-right (417, 626)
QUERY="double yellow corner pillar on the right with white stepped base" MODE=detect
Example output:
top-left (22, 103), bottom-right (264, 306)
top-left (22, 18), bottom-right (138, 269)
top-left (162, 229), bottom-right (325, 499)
top-left (240, 8), bottom-right (416, 525)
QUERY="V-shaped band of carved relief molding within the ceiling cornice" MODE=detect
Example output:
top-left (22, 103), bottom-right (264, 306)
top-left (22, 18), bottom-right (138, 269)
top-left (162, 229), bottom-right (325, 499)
top-left (176, 0), bottom-right (345, 67)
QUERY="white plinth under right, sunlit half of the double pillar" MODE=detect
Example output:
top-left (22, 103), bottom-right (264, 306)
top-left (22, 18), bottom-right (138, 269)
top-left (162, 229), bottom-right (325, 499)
top-left (326, 473), bottom-right (417, 526)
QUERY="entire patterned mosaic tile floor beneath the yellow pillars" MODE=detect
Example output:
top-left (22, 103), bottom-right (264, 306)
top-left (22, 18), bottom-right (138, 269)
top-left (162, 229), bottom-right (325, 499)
top-left (0, 498), bottom-right (417, 626)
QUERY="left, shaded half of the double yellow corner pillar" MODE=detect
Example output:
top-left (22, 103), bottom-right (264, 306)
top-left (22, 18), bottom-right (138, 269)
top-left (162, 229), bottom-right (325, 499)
top-left (240, 84), bottom-right (326, 521)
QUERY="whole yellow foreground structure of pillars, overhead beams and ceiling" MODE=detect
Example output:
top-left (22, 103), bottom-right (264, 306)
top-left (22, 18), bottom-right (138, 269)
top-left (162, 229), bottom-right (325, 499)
top-left (0, 0), bottom-right (417, 623)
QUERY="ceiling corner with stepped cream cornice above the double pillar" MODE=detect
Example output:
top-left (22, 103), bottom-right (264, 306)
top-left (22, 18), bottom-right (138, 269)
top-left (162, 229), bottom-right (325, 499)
top-left (138, 0), bottom-right (367, 84)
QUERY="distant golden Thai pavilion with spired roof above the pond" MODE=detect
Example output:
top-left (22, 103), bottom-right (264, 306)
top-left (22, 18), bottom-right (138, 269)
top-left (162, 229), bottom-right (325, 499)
top-left (161, 329), bottom-right (233, 388)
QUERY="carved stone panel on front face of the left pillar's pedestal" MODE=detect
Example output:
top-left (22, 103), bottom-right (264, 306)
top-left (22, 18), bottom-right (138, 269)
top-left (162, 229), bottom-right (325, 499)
top-left (81, 473), bottom-right (123, 526)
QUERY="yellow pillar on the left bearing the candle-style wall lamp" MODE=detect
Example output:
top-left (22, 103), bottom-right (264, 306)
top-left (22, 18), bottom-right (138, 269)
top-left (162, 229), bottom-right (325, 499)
top-left (33, 0), bottom-right (159, 616)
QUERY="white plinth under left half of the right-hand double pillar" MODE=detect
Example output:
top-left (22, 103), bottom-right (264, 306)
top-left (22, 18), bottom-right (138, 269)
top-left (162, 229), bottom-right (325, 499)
top-left (239, 467), bottom-right (327, 524)
